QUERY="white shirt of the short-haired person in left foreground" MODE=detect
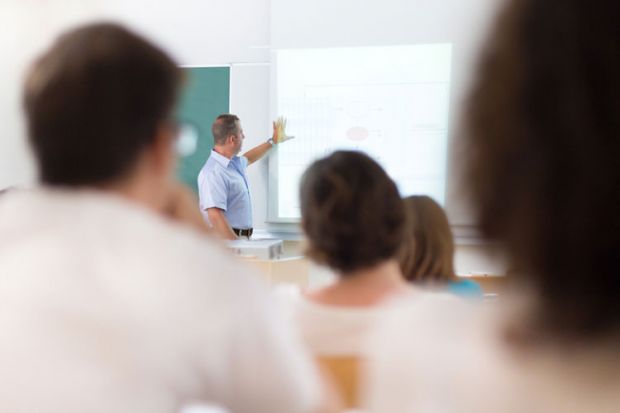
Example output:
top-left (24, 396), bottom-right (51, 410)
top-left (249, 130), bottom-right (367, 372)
top-left (0, 189), bottom-right (320, 413)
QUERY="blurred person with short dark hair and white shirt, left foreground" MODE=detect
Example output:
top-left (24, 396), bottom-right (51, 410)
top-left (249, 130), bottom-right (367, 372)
top-left (0, 23), bottom-right (334, 413)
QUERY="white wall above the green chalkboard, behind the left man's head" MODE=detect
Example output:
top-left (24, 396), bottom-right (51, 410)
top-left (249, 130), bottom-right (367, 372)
top-left (0, 0), bottom-right (269, 188)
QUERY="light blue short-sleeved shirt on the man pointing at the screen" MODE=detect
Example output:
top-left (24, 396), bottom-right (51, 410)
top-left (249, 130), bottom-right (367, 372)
top-left (198, 150), bottom-right (252, 229)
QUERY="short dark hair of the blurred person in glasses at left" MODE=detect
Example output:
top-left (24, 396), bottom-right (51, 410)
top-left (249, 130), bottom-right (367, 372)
top-left (24, 23), bottom-right (180, 186)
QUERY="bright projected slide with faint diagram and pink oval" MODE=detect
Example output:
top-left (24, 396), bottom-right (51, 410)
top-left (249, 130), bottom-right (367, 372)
top-left (270, 44), bottom-right (451, 220)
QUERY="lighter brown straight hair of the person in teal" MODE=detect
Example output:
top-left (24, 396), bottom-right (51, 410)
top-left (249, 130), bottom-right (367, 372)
top-left (399, 195), bottom-right (456, 282)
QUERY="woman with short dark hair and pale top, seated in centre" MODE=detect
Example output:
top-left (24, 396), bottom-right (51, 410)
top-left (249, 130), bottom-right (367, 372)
top-left (285, 151), bottom-right (417, 407)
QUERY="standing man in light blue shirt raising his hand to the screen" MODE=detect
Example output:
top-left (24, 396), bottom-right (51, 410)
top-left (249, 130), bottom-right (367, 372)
top-left (198, 114), bottom-right (291, 239)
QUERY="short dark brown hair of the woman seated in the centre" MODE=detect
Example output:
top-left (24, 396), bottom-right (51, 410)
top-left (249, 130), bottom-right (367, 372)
top-left (301, 151), bottom-right (405, 273)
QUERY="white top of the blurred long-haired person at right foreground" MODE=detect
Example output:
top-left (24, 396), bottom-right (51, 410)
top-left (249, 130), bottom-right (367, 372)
top-left (364, 295), bottom-right (620, 413)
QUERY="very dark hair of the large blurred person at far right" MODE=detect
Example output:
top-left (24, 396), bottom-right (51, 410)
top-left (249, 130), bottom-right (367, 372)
top-left (467, 0), bottom-right (620, 338)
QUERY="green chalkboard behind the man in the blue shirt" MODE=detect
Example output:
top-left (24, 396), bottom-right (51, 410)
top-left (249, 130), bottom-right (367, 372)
top-left (177, 67), bottom-right (230, 192)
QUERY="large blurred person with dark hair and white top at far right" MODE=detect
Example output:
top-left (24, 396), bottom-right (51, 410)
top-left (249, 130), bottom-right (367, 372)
top-left (368, 0), bottom-right (620, 413)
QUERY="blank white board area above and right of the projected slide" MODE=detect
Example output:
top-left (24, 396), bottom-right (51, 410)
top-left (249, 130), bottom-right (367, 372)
top-left (270, 0), bottom-right (504, 226)
